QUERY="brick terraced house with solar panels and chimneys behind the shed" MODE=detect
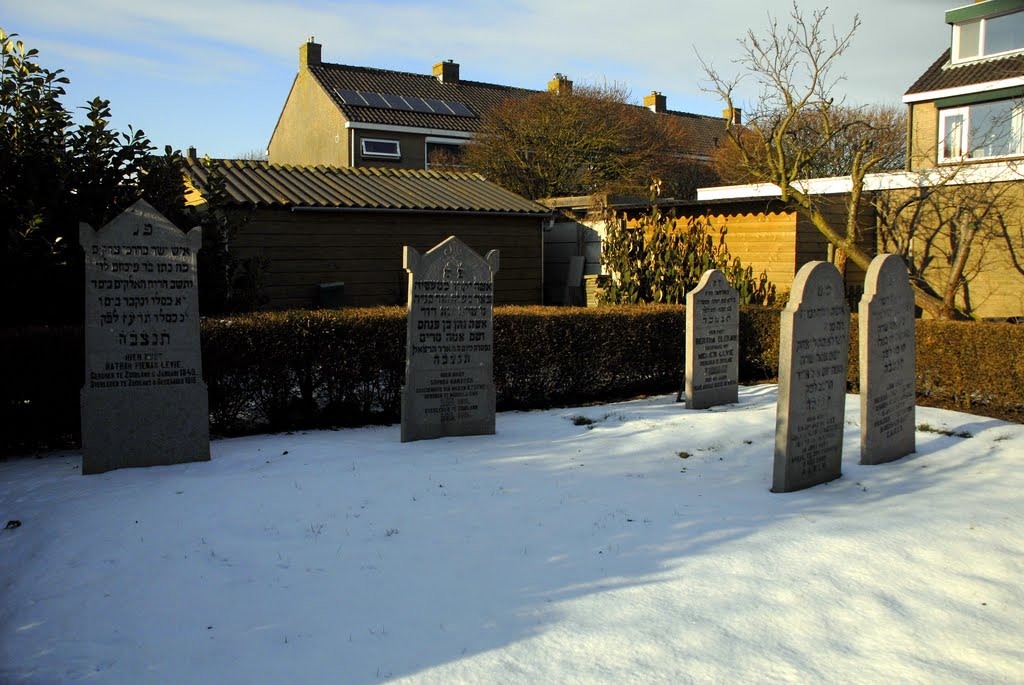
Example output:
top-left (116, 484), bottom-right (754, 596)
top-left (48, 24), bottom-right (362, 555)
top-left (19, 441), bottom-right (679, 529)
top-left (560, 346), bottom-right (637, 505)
top-left (267, 37), bottom-right (725, 174)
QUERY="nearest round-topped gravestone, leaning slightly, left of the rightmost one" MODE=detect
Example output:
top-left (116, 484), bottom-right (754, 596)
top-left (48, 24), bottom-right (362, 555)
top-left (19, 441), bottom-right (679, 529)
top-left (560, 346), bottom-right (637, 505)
top-left (771, 262), bottom-right (850, 493)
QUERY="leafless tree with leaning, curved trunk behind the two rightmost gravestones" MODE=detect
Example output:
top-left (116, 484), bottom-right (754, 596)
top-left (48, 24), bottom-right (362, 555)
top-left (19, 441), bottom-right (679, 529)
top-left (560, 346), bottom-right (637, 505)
top-left (702, 3), bottom-right (970, 317)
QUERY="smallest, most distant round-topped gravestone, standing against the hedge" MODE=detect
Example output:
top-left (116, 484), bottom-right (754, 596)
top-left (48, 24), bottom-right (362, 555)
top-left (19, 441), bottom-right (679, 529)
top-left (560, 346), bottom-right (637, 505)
top-left (686, 269), bottom-right (739, 410)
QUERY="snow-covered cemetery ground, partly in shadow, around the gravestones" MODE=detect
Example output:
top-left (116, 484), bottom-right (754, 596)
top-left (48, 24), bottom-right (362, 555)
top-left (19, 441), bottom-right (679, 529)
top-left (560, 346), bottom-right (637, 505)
top-left (0, 385), bottom-right (1024, 684)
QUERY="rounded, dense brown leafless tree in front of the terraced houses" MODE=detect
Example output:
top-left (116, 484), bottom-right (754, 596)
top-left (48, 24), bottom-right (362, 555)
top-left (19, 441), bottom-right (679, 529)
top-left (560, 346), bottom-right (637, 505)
top-left (462, 85), bottom-right (693, 199)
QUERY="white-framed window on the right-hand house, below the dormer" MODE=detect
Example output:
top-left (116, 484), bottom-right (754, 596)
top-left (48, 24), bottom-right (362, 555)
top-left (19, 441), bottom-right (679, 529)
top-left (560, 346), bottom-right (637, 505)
top-left (939, 98), bottom-right (1024, 162)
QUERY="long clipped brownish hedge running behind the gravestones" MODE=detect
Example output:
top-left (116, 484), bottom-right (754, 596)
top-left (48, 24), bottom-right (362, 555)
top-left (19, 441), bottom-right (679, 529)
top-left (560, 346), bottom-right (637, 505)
top-left (0, 305), bottom-right (1024, 454)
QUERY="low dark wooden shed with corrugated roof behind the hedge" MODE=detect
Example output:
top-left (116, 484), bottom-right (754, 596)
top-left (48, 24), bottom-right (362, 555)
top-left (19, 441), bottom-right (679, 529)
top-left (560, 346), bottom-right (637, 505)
top-left (186, 158), bottom-right (551, 309)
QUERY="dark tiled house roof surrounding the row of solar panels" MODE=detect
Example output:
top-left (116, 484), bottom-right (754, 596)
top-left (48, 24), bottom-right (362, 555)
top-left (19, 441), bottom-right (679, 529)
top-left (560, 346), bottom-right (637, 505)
top-left (309, 63), bottom-right (538, 133)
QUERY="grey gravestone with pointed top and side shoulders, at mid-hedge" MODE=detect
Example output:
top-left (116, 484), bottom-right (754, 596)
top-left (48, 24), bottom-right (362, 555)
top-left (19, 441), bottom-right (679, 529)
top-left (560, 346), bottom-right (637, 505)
top-left (401, 236), bottom-right (499, 442)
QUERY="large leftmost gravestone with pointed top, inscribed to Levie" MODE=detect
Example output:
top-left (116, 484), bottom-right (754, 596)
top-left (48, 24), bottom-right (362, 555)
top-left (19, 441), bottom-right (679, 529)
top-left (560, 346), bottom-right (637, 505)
top-left (79, 200), bottom-right (210, 474)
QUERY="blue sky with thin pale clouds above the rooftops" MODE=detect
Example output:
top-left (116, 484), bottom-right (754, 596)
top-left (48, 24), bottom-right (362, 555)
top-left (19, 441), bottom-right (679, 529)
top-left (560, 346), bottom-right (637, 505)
top-left (6, 0), bottom-right (966, 158)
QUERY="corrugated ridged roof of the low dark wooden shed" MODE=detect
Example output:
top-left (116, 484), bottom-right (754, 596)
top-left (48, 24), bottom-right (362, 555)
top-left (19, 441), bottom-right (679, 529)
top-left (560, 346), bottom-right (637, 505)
top-left (185, 158), bottom-right (550, 215)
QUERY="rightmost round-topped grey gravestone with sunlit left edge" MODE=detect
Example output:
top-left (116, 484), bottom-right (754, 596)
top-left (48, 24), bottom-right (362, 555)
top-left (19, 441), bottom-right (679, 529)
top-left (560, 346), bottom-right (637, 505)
top-left (859, 255), bottom-right (916, 464)
